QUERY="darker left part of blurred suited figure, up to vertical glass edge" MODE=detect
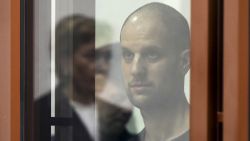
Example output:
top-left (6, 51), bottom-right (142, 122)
top-left (35, 15), bottom-right (97, 141)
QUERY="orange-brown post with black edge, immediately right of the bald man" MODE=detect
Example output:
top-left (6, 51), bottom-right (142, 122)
top-left (190, 0), bottom-right (218, 141)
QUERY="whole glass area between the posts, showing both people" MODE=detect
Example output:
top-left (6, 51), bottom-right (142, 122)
top-left (33, 0), bottom-right (190, 141)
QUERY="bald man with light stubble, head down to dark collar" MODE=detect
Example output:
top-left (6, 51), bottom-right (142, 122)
top-left (120, 3), bottom-right (190, 141)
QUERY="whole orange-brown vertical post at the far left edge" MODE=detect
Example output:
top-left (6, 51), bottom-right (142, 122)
top-left (0, 0), bottom-right (20, 141)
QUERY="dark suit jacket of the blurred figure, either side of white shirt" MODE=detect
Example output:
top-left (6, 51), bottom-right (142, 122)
top-left (35, 87), bottom-right (135, 141)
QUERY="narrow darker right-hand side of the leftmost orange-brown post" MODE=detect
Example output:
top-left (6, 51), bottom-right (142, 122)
top-left (10, 0), bottom-right (21, 141)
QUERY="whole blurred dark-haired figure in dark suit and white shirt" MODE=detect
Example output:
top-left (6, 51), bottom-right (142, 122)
top-left (34, 15), bottom-right (133, 141)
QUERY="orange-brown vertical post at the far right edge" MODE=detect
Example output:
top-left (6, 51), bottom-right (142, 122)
top-left (223, 0), bottom-right (249, 141)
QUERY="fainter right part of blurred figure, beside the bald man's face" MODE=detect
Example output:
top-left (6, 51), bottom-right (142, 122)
top-left (95, 43), bottom-right (134, 141)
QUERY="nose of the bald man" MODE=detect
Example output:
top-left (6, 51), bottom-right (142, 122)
top-left (131, 56), bottom-right (146, 77)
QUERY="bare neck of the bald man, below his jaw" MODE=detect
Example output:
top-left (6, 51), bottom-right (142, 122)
top-left (141, 94), bottom-right (189, 141)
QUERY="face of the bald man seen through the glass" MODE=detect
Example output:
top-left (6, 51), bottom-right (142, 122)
top-left (121, 17), bottom-right (180, 107)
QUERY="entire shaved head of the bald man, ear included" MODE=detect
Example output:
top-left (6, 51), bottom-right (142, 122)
top-left (120, 3), bottom-right (189, 108)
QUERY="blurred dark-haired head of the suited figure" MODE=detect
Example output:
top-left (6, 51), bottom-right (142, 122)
top-left (55, 15), bottom-right (95, 100)
